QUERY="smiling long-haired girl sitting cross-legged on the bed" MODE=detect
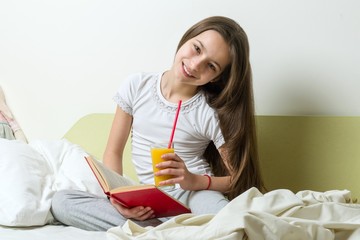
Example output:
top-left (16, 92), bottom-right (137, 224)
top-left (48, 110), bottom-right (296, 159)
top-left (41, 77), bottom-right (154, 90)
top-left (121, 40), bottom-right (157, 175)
top-left (52, 16), bottom-right (263, 230)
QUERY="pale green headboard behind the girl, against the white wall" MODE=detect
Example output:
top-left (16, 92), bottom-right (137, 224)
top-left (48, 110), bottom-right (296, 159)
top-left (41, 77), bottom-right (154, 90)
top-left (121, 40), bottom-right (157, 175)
top-left (64, 114), bottom-right (360, 198)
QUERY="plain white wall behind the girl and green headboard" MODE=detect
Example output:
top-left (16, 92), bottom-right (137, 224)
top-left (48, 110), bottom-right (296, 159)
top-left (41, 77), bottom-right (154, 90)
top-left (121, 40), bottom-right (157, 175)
top-left (0, 0), bottom-right (360, 140)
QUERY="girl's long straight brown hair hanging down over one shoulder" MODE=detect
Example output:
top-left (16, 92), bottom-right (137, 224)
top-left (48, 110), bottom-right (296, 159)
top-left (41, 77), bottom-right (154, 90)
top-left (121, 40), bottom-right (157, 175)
top-left (177, 16), bottom-right (264, 199)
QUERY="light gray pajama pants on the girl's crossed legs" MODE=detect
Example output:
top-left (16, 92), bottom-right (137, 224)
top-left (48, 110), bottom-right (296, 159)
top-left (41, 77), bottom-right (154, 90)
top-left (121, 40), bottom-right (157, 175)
top-left (51, 188), bottom-right (228, 231)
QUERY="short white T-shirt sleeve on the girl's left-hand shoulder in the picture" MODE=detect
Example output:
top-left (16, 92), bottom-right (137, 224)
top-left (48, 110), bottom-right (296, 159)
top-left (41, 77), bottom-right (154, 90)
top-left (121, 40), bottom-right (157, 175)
top-left (113, 74), bottom-right (140, 115)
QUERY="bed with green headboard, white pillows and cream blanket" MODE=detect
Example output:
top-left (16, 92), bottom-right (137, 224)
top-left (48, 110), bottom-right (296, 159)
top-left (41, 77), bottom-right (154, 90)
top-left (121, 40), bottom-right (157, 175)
top-left (0, 113), bottom-right (360, 240)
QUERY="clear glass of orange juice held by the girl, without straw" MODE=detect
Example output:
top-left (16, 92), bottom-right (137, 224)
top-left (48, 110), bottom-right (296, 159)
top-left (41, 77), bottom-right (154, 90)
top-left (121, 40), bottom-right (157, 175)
top-left (151, 143), bottom-right (174, 187)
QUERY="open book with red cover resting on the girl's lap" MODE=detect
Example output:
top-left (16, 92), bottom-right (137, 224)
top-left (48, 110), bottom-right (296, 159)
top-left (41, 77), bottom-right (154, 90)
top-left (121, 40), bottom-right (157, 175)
top-left (85, 157), bottom-right (191, 218)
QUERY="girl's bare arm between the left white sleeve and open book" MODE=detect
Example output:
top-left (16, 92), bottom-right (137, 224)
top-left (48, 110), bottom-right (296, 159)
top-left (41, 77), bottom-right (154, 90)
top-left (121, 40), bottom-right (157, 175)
top-left (104, 107), bottom-right (132, 175)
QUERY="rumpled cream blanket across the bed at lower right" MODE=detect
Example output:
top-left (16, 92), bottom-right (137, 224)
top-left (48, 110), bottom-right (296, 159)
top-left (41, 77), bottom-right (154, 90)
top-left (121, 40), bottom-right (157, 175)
top-left (108, 188), bottom-right (360, 240)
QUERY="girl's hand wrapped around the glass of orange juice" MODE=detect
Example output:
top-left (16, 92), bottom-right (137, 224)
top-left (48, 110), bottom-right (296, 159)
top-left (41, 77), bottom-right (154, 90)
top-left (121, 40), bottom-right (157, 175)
top-left (155, 153), bottom-right (199, 190)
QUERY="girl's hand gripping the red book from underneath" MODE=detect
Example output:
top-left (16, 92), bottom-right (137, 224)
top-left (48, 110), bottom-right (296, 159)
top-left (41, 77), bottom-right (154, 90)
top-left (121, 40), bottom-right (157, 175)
top-left (110, 198), bottom-right (155, 221)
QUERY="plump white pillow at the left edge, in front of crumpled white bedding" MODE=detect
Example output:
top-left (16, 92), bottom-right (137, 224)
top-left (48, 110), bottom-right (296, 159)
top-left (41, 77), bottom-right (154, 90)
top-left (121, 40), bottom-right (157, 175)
top-left (0, 139), bottom-right (53, 226)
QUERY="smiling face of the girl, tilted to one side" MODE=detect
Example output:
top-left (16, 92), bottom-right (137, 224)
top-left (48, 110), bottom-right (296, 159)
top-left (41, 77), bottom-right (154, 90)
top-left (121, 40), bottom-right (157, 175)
top-left (173, 30), bottom-right (230, 86)
